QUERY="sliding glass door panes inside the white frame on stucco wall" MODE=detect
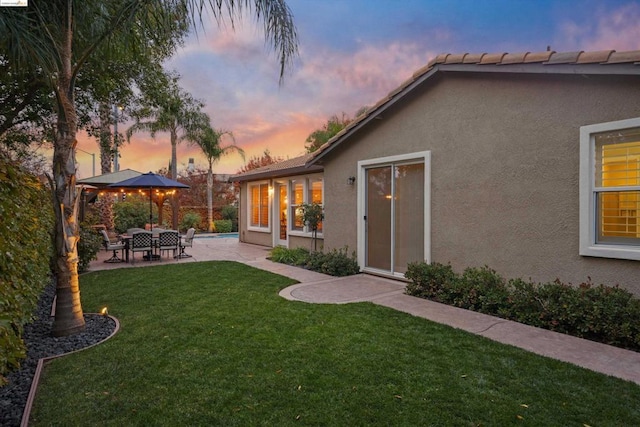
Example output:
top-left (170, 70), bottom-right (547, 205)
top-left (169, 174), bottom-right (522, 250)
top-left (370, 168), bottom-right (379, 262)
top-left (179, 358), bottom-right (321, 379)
top-left (365, 163), bottom-right (424, 274)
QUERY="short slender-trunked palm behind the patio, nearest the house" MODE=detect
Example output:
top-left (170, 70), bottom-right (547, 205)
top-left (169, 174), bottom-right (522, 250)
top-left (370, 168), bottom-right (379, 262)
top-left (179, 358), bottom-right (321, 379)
top-left (187, 126), bottom-right (244, 232)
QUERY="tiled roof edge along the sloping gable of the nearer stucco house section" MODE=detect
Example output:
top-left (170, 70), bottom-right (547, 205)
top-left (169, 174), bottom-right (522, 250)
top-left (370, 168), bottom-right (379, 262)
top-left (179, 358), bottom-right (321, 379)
top-left (307, 50), bottom-right (640, 167)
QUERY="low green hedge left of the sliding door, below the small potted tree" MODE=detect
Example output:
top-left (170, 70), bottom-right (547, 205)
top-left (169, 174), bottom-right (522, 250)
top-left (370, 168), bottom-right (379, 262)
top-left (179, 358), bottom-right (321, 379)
top-left (269, 246), bottom-right (360, 277)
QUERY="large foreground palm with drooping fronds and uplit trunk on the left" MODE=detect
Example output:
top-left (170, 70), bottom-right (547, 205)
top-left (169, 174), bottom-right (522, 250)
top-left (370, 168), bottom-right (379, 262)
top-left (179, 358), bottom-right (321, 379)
top-left (0, 0), bottom-right (297, 336)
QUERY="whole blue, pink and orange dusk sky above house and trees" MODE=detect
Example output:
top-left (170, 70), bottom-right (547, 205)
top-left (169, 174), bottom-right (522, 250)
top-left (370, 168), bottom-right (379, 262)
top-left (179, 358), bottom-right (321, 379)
top-left (72, 0), bottom-right (640, 178)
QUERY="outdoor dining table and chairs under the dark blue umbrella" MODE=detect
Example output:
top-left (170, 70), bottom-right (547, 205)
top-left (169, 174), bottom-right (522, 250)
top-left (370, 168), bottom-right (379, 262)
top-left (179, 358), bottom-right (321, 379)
top-left (100, 228), bottom-right (196, 263)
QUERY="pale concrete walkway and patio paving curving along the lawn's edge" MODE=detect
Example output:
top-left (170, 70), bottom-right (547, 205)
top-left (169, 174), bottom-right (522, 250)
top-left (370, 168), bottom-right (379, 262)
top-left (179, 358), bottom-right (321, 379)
top-left (91, 236), bottom-right (640, 385)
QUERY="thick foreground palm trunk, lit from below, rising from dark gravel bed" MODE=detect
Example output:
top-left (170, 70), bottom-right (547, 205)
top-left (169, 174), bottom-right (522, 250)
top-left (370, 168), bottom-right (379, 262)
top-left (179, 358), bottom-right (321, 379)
top-left (52, 2), bottom-right (85, 336)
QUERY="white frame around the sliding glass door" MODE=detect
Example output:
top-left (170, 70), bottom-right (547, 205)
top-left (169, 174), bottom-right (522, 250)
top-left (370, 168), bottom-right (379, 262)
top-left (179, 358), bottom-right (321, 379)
top-left (356, 151), bottom-right (431, 277)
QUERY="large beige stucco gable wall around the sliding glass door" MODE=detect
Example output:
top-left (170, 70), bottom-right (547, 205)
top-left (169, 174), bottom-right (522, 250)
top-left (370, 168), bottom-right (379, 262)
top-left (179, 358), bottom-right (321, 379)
top-left (324, 73), bottom-right (640, 295)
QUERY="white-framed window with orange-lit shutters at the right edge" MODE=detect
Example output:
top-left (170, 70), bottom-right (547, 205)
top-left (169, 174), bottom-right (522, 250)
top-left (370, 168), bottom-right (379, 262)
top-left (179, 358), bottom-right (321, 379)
top-left (580, 118), bottom-right (640, 260)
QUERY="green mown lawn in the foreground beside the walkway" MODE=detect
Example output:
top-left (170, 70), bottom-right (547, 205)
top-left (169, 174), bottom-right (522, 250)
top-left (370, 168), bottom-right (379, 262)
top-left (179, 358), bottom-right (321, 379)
top-left (30, 262), bottom-right (640, 426)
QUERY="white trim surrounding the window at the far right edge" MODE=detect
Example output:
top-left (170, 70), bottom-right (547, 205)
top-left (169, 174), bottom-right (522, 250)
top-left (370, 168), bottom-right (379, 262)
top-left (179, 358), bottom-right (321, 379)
top-left (580, 117), bottom-right (640, 261)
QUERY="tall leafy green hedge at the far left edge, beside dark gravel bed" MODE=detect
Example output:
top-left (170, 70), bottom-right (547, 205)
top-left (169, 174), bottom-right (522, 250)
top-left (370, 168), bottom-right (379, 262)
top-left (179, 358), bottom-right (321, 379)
top-left (0, 152), bottom-right (55, 386)
